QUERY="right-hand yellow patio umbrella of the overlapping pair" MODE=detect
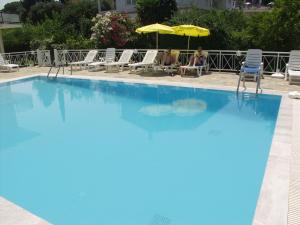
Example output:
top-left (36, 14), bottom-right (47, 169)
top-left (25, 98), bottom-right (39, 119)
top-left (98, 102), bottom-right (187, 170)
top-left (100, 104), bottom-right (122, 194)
top-left (172, 25), bottom-right (210, 50)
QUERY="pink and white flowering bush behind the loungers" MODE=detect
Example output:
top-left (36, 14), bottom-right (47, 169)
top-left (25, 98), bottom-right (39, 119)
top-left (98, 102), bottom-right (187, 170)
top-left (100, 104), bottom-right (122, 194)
top-left (91, 12), bottom-right (133, 48)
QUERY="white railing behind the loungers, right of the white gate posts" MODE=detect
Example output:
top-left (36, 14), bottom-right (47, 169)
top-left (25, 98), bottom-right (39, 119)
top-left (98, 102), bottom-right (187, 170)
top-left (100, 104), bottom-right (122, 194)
top-left (56, 49), bottom-right (289, 74)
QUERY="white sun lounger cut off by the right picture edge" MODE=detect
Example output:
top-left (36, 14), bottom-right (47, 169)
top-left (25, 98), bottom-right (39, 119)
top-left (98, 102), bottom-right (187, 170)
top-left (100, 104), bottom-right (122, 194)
top-left (285, 50), bottom-right (300, 84)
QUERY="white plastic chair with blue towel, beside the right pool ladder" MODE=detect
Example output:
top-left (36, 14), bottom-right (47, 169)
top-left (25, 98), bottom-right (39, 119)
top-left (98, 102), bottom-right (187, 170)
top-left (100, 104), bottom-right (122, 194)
top-left (237, 49), bottom-right (264, 93)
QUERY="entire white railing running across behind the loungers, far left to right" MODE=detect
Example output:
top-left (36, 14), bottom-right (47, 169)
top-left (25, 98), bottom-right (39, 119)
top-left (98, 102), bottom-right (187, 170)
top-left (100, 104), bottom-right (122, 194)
top-left (3, 49), bottom-right (289, 74)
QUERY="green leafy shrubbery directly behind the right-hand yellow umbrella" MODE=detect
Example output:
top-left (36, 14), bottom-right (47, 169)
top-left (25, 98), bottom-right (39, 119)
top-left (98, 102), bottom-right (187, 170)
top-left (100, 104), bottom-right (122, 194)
top-left (166, 8), bottom-right (248, 49)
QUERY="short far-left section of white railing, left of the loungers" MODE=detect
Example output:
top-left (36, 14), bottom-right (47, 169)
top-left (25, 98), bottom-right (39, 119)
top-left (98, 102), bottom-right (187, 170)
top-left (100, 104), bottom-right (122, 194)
top-left (2, 50), bottom-right (51, 66)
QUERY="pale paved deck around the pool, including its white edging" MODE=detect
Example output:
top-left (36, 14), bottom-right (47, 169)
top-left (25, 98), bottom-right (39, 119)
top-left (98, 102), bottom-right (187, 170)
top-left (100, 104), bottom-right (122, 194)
top-left (0, 67), bottom-right (300, 225)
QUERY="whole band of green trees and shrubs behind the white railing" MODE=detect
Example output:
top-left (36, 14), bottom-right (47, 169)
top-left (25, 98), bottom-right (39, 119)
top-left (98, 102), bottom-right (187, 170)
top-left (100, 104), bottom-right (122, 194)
top-left (3, 0), bottom-right (300, 51)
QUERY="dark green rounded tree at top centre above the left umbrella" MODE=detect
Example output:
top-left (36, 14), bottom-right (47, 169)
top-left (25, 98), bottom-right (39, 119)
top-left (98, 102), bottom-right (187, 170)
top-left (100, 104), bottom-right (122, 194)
top-left (136, 0), bottom-right (177, 25)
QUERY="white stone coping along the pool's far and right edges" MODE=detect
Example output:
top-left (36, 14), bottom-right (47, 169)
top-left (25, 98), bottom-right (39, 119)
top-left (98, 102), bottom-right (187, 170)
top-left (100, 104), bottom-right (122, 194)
top-left (0, 73), bottom-right (294, 225)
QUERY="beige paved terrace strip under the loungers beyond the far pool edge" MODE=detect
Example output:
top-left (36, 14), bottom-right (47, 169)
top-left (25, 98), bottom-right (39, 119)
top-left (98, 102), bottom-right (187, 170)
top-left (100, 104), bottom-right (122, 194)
top-left (0, 67), bottom-right (300, 92)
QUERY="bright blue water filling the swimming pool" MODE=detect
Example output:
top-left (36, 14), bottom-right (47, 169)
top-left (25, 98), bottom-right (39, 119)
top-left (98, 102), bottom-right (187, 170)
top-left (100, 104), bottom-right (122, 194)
top-left (0, 78), bottom-right (281, 225)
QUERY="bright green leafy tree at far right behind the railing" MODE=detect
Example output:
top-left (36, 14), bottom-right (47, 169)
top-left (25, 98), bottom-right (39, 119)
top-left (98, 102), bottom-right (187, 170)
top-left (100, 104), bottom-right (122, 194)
top-left (247, 0), bottom-right (300, 51)
